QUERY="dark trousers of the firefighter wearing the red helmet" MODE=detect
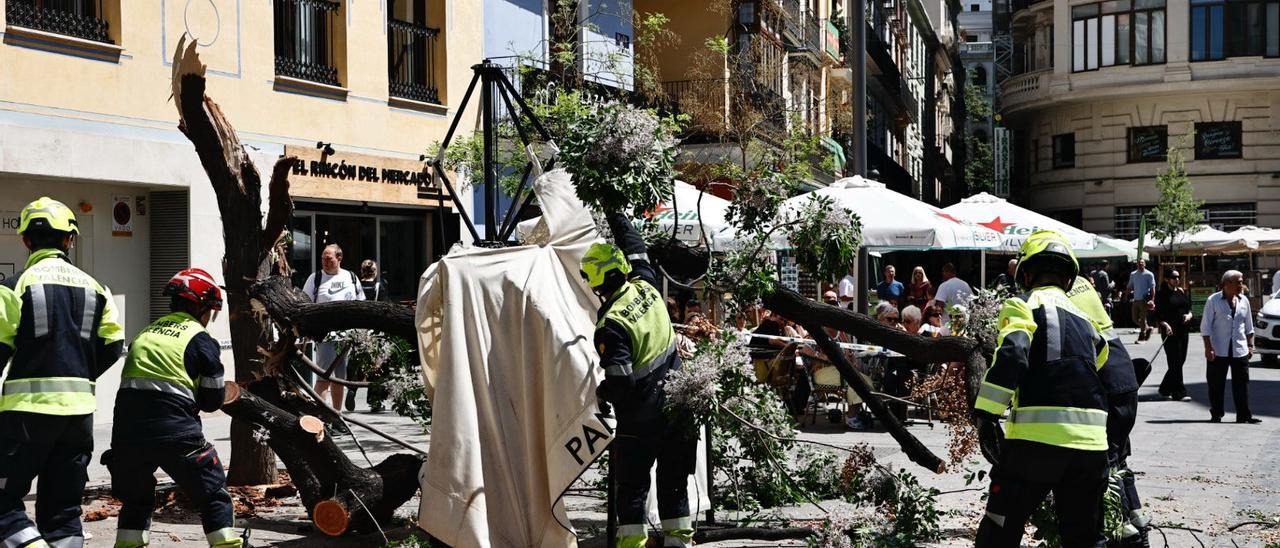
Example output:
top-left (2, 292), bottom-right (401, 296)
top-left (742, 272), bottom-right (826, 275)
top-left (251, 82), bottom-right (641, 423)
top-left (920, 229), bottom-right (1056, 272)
top-left (102, 439), bottom-right (236, 534)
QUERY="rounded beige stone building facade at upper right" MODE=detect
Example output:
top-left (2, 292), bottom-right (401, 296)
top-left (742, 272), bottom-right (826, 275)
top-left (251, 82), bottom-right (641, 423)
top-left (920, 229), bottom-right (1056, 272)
top-left (1001, 0), bottom-right (1280, 238)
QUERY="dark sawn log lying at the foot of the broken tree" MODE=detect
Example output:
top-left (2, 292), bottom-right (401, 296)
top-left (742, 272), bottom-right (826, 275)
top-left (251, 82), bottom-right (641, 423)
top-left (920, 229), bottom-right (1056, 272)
top-left (223, 379), bottom-right (425, 535)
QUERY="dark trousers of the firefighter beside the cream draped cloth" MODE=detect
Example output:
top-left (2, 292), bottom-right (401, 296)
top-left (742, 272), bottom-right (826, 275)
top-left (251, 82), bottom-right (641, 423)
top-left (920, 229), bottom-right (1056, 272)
top-left (609, 420), bottom-right (698, 525)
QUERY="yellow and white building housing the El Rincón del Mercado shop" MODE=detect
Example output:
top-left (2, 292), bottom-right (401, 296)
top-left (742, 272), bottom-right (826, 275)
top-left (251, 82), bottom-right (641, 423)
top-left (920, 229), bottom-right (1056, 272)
top-left (0, 0), bottom-right (483, 420)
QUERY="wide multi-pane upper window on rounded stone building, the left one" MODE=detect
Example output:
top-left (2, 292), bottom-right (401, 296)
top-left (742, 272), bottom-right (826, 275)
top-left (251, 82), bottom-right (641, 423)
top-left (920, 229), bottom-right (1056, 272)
top-left (1071, 0), bottom-right (1167, 72)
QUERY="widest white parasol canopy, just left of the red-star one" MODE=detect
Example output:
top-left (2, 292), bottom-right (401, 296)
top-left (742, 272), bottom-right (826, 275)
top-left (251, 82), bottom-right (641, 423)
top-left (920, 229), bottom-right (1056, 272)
top-left (782, 175), bottom-right (1000, 250)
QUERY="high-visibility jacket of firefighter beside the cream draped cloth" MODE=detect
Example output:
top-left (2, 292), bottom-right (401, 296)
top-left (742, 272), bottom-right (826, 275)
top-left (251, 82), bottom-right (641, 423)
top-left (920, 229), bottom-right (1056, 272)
top-left (595, 280), bottom-right (676, 379)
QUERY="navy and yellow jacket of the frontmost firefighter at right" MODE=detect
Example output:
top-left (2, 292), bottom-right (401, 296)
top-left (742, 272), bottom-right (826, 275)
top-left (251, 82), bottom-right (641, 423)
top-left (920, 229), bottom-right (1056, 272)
top-left (974, 286), bottom-right (1107, 451)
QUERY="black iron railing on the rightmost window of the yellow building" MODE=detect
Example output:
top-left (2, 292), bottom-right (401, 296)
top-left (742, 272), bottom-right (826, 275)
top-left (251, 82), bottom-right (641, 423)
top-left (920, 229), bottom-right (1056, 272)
top-left (387, 19), bottom-right (440, 104)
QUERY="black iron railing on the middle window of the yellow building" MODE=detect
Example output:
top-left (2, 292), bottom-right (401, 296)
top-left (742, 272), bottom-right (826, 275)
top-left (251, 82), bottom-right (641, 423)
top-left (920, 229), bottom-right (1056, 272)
top-left (275, 0), bottom-right (339, 86)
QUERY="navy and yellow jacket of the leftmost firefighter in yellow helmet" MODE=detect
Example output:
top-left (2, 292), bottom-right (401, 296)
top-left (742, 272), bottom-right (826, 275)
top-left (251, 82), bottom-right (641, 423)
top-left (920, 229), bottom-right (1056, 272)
top-left (0, 248), bottom-right (124, 415)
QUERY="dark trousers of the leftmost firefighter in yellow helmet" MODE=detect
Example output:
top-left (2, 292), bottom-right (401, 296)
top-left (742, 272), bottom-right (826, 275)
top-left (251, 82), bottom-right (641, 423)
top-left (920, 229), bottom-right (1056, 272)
top-left (0, 411), bottom-right (93, 547)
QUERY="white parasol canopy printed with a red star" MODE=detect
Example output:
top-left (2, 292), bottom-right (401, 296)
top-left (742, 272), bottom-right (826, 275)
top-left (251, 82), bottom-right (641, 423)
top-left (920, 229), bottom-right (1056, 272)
top-left (943, 192), bottom-right (1100, 250)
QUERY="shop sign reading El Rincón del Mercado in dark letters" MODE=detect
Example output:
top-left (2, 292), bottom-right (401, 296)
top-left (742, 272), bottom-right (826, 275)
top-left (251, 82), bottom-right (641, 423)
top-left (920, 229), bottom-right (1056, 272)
top-left (284, 146), bottom-right (444, 205)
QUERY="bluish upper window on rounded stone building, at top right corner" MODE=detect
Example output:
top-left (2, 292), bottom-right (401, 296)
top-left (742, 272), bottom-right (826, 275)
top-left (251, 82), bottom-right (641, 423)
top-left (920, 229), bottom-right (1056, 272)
top-left (1190, 0), bottom-right (1280, 61)
